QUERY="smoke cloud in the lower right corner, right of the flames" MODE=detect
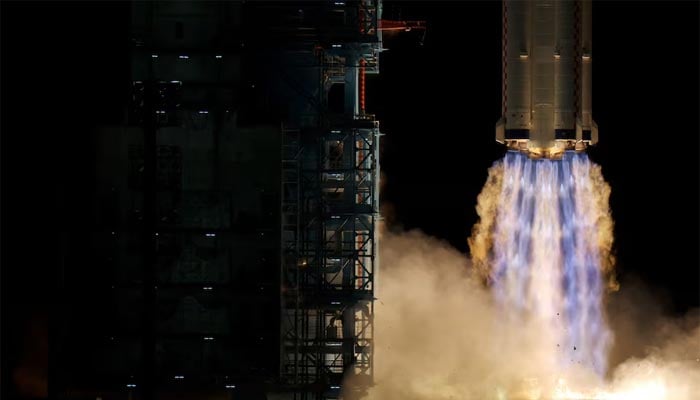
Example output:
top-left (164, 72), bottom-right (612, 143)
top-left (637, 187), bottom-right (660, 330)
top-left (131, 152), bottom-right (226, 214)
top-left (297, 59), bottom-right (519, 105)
top-left (608, 278), bottom-right (700, 400)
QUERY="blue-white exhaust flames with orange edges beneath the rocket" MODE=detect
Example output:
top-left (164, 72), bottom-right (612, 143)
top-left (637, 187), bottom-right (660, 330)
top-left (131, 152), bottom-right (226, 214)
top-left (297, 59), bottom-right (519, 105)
top-left (470, 152), bottom-right (612, 376)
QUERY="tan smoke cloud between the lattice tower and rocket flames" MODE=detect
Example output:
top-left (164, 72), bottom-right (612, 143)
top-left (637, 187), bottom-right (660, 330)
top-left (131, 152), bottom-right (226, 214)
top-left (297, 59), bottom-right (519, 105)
top-left (346, 232), bottom-right (580, 400)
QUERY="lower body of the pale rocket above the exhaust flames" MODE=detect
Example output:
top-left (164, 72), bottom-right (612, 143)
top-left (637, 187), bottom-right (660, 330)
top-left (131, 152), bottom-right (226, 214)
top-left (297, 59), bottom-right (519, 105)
top-left (496, 0), bottom-right (598, 158)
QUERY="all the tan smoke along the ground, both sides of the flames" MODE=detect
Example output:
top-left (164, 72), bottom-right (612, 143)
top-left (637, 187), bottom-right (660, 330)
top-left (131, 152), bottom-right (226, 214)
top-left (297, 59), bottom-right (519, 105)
top-left (350, 231), bottom-right (700, 400)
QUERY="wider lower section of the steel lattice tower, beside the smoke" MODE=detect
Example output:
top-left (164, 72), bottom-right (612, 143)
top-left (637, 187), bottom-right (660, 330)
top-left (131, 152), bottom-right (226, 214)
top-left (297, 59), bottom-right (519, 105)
top-left (281, 117), bottom-right (379, 399)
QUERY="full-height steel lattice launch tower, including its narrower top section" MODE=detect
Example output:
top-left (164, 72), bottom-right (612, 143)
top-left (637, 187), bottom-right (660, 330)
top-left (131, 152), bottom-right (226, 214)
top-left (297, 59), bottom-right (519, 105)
top-left (280, 0), bottom-right (381, 400)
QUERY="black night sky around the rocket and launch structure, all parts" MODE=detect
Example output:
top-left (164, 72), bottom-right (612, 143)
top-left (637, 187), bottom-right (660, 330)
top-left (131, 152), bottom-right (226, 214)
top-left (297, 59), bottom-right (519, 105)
top-left (1, 1), bottom-right (700, 396)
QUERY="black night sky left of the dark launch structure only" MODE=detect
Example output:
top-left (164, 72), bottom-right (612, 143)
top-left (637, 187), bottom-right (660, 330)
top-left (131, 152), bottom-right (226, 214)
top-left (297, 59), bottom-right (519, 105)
top-left (0, 1), bottom-right (129, 398)
